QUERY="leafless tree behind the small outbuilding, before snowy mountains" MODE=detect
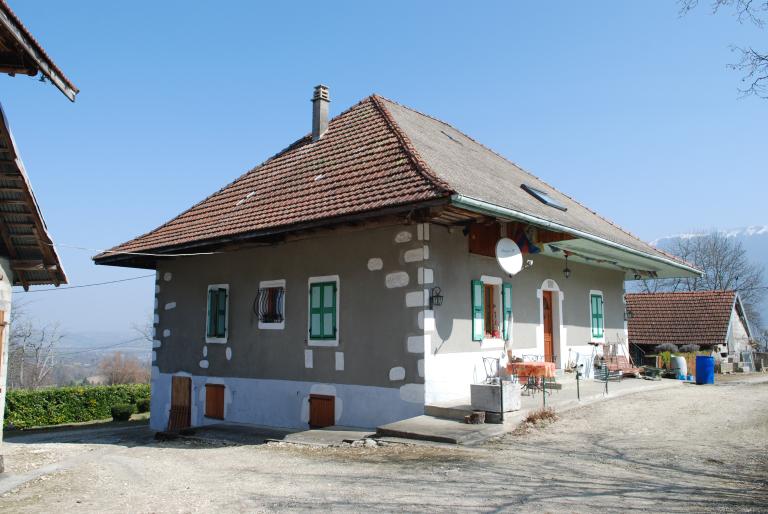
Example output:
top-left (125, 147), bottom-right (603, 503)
top-left (641, 232), bottom-right (768, 328)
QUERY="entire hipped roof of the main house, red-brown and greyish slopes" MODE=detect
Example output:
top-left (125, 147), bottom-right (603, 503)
top-left (95, 95), bottom-right (688, 276)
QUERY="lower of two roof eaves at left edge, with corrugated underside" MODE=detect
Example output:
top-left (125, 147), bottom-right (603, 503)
top-left (0, 105), bottom-right (67, 289)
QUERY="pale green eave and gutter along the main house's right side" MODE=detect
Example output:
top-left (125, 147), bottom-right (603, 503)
top-left (451, 194), bottom-right (702, 280)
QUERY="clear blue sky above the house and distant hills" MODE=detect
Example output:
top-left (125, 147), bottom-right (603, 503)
top-left (0, 0), bottom-right (768, 332)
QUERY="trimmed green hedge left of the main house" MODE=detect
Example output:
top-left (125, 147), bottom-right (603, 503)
top-left (4, 384), bottom-right (149, 428)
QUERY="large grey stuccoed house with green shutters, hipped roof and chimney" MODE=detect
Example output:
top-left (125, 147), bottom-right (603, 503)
top-left (95, 86), bottom-right (698, 430)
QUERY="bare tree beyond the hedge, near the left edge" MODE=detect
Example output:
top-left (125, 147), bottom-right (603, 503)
top-left (8, 305), bottom-right (63, 389)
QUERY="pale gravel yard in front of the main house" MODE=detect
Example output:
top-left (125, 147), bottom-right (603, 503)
top-left (0, 377), bottom-right (768, 513)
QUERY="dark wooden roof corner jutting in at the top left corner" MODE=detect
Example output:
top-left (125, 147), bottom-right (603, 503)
top-left (0, 0), bottom-right (80, 102)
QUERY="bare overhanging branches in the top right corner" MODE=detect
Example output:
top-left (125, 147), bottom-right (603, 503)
top-left (679, 0), bottom-right (768, 98)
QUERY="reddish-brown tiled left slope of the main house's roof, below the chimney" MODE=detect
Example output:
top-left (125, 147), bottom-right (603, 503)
top-left (96, 96), bottom-right (448, 260)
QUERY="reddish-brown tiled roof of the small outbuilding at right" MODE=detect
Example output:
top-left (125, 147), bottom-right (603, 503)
top-left (626, 291), bottom-right (736, 345)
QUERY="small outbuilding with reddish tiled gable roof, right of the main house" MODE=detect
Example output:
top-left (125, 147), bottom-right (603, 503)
top-left (626, 291), bottom-right (753, 369)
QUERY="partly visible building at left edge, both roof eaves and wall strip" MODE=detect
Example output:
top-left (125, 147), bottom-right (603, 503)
top-left (0, 0), bottom-right (78, 448)
